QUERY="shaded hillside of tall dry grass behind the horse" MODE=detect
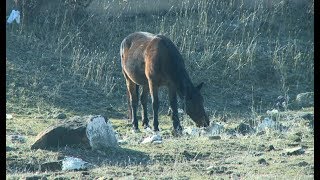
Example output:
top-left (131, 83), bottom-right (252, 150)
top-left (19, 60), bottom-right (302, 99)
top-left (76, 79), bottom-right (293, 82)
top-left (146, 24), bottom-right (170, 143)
top-left (6, 1), bottom-right (314, 116)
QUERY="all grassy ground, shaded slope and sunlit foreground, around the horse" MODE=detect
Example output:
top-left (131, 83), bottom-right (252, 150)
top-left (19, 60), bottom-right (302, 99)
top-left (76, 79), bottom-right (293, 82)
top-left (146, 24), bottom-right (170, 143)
top-left (6, 0), bottom-right (314, 179)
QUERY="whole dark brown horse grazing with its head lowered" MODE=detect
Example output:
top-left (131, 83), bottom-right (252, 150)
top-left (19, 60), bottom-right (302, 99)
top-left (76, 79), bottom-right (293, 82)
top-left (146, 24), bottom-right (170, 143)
top-left (120, 32), bottom-right (209, 133)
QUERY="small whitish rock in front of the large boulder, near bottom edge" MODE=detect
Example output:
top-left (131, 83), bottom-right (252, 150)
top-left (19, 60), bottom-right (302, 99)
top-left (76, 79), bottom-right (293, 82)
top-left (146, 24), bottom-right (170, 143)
top-left (62, 156), bottom-right (93, 171)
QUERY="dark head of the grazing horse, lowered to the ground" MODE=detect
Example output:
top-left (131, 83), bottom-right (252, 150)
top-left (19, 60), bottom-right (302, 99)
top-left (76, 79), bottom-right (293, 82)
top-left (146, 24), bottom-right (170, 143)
top-left (185, 83), bottom-right (209, 127)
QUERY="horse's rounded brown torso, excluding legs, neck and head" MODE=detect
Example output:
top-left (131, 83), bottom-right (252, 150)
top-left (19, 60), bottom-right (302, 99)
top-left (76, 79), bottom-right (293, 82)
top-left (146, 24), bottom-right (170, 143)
top-left (120, 32), bottom-right (184, 84)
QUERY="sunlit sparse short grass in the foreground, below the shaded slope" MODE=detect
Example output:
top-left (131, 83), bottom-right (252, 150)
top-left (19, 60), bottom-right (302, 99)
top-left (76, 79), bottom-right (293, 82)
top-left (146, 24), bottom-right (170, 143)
top-left (7, 111), bottom-right (314, 179)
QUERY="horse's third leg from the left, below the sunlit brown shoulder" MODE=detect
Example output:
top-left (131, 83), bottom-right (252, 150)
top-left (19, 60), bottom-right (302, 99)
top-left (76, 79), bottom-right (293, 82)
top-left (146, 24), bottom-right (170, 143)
top-left (149, 81), bottom-right (159, 132)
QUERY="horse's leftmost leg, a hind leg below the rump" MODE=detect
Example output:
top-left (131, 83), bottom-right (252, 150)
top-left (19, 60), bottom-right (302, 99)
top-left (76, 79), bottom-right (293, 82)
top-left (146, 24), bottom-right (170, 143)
top-left (126, 79), bottom-right (139, 131)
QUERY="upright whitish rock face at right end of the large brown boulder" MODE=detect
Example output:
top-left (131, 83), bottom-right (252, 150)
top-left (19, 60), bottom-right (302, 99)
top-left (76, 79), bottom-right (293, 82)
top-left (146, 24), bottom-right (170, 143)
top-left (86, 116), bottom-right (119, 149)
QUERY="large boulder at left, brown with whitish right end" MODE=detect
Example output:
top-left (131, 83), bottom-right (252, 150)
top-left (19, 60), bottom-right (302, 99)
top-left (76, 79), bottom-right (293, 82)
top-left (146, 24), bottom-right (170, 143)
top-left (31, 116), bottom-right (118, 149)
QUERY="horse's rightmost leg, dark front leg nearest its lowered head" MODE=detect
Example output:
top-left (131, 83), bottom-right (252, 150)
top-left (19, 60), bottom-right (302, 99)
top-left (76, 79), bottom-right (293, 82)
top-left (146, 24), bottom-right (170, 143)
top-left (169, 88), bottom-right (182, 135)
